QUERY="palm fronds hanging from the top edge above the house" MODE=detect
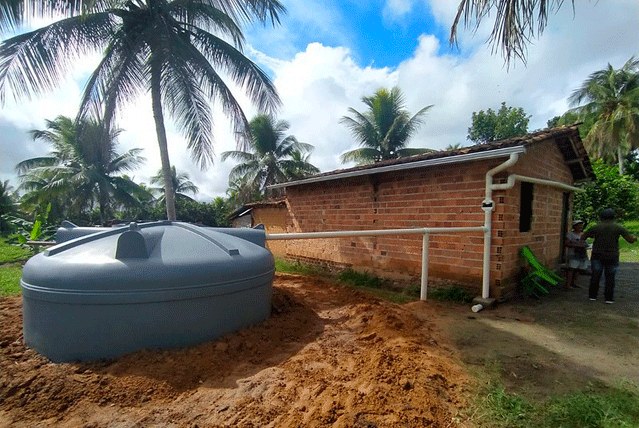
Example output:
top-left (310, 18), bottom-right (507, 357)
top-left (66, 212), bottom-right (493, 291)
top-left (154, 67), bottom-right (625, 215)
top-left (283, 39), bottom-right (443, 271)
top-left (450, 0), bottom-right (575, 64)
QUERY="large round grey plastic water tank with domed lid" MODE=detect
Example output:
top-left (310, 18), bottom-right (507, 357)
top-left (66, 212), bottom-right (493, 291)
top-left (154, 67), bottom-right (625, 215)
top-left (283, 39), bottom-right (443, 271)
top-left (21, 222), bottom-right (275, 362)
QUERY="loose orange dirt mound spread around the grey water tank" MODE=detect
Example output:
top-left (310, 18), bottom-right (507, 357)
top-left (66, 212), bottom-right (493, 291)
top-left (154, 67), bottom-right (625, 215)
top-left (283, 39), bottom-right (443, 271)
top-left (0, 275), bottom-right (468, 427)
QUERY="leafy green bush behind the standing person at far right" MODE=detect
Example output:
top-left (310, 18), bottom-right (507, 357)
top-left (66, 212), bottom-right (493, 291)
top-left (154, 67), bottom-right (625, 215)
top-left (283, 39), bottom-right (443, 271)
top-left (574, 160), bottom-right (639, 223)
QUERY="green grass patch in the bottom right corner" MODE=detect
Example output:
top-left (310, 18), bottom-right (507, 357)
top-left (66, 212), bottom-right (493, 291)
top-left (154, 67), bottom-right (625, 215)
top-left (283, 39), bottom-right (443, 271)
top-left (470, 370), bottom-right (639, 428)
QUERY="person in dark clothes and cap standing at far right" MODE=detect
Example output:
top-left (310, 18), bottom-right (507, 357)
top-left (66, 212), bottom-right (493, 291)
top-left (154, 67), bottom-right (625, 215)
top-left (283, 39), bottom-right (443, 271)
top-left (581, 208), bottom-right (637, 304)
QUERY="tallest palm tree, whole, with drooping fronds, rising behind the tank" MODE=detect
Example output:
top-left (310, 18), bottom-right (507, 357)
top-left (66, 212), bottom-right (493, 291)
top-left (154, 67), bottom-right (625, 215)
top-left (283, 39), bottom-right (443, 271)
top-left (0, 0), bottom-right (285, 220)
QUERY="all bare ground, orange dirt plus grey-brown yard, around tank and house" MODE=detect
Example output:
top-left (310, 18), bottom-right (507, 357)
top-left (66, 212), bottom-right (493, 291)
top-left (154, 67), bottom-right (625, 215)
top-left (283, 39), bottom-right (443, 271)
top-left (0, 265), bottom-right (639, 427)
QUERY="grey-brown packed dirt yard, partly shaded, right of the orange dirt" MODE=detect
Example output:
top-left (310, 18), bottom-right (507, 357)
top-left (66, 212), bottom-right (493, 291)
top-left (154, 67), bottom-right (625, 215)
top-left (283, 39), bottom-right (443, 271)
top-left (412, 263), bottom-right (639, 399)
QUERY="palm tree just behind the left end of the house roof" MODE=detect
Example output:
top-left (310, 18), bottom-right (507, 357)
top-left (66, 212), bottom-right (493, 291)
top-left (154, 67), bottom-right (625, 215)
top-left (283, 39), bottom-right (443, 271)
top-left (222, 114), bottom-right (316, 197)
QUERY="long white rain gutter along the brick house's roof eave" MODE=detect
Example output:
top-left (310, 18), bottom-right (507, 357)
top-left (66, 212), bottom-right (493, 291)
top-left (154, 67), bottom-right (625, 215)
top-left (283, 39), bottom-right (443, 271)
top-left (266, 146), bottom-right (526, 189)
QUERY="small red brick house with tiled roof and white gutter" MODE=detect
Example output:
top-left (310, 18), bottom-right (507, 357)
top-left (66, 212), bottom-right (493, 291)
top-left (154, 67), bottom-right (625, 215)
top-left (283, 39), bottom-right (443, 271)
top-left (241, 126), bottom-right (593, 297)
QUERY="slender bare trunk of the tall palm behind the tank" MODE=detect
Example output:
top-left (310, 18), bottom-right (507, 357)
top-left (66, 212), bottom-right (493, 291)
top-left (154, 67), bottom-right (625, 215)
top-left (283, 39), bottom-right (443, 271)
top-left (151, 61), bottom-right (176, 221)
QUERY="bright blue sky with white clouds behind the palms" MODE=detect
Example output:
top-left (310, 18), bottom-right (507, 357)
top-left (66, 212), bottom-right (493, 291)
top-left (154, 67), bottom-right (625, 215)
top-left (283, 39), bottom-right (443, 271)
top-left (0, 0), bottom-right (639, 200)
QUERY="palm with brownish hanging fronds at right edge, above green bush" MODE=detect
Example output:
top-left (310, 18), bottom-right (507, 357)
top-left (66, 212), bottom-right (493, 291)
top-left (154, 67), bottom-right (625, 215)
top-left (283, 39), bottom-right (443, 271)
top-left (569, 57), bottom-right (639, 174)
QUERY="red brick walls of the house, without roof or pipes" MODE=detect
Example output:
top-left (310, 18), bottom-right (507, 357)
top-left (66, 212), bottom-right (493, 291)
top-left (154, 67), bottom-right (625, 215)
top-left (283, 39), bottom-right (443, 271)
top-left (270, 142), bottom-right (572, 296)
